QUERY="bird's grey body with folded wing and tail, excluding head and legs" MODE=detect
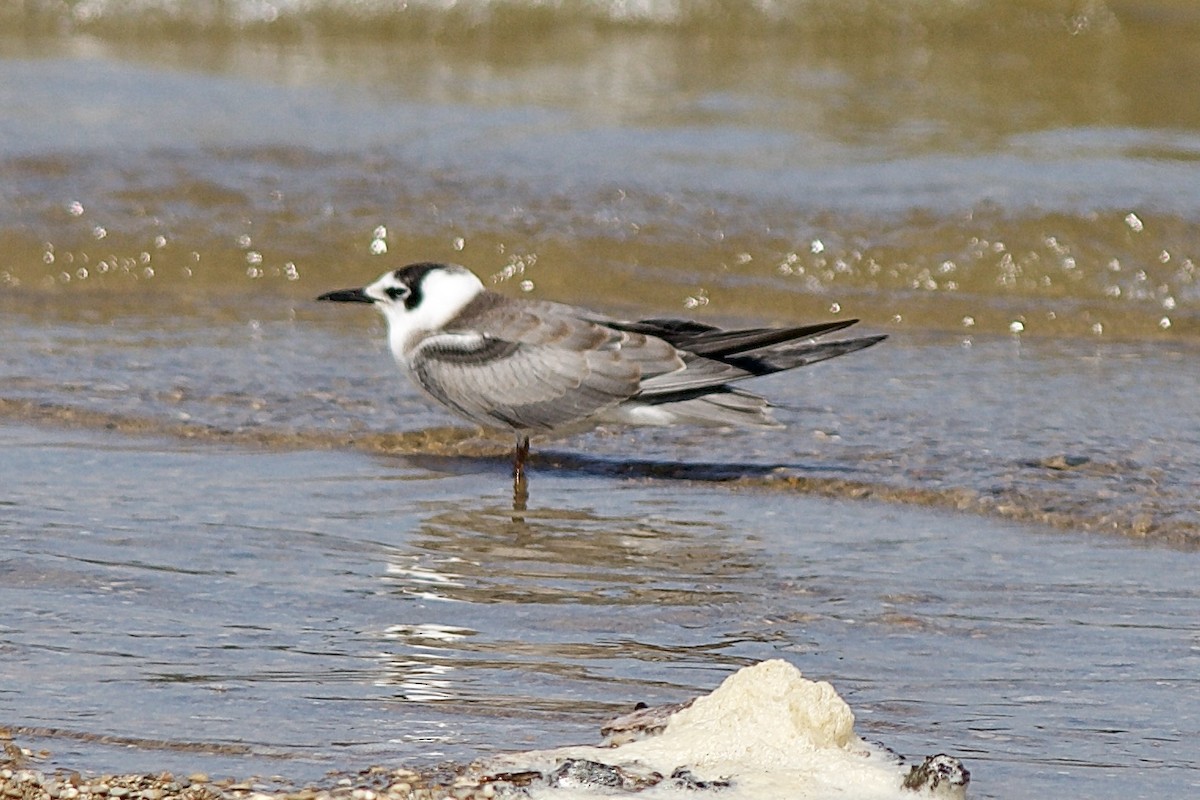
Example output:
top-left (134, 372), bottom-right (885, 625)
top-left (406, 293), bottom-right (884, 431)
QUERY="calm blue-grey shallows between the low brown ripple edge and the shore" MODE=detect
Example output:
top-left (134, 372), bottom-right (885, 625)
top-left (0, 426), bottom-right (1200, 796)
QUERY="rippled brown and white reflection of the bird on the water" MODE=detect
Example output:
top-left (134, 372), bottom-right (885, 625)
top-left (379, 488), bottom-right (766, 715)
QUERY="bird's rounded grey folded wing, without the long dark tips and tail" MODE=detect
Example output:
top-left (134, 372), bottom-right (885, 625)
top-left (408, 294), bottom-right (684, 431)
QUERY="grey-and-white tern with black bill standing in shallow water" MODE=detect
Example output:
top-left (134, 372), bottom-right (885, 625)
top-left (317, 261), bottom-right (887, 486)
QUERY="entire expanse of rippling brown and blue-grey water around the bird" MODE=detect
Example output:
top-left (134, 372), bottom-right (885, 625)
top-left (0, 0), bottom-right (1200, 798)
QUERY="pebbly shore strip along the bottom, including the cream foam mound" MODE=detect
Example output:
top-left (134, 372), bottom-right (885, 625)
top-left (0, 658), bottom-right (971, 800)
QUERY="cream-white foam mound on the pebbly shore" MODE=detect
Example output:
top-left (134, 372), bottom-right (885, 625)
top-left (484, 660), bottom-right (955, 800)
